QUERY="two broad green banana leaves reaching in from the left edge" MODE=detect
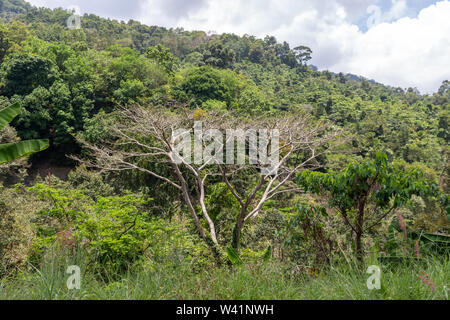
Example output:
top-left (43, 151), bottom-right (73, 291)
top-left (0, 103), bottom-right (49, 164)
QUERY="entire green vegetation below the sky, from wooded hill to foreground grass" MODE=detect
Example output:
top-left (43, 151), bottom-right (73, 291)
top-left (0, 0), bottom-right (450, 299)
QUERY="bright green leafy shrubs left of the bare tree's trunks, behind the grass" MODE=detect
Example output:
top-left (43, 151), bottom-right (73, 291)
top-left (0, 179), bottom-right (212, 274)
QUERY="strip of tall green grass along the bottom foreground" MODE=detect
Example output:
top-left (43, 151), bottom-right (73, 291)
top-left (0, 258), bottom-right (450, 300)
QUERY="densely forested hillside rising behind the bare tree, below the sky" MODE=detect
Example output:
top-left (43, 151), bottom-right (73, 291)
top-left (1, 2), bottom-right (450, 169)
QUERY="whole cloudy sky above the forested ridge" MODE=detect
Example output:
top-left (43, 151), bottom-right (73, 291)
top-left (28, 0), bottom-right (450, 93)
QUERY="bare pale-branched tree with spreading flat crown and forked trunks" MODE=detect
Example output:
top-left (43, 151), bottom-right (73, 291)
top-left (76, 107), bottom-right (342, 255)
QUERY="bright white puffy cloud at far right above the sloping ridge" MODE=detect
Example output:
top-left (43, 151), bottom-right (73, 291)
top-left (329, 1), bottom-right (450, 93)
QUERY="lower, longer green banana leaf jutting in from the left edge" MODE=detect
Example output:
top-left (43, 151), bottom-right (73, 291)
top-left (0, 139), bottom-right (49, 164)
